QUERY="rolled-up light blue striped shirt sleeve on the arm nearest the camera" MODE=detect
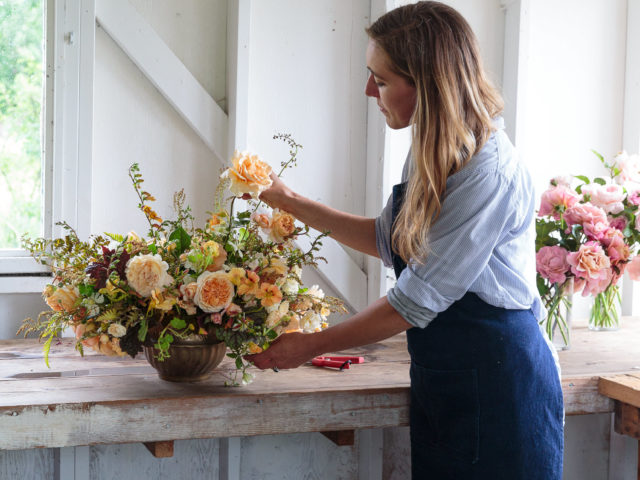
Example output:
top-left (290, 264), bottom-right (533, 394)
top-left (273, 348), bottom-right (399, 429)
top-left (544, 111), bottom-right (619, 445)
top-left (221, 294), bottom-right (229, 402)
top-left (387, 165), bottom-right (517, 328)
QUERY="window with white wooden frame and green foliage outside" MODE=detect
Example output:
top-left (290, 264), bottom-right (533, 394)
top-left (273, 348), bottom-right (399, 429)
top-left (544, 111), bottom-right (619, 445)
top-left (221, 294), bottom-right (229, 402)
top-left (0, 0), bottom-right (95, 293)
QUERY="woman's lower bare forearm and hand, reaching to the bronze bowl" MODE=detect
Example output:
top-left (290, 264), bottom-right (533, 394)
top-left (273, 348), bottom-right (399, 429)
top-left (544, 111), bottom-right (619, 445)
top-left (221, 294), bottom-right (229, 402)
top-left (245, 297), bottom-right (412, 369)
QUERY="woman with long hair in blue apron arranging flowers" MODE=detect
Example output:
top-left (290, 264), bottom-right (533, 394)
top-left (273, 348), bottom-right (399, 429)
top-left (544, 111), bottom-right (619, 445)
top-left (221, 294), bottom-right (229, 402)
top-left (247, 2), bottom-right (563, 480)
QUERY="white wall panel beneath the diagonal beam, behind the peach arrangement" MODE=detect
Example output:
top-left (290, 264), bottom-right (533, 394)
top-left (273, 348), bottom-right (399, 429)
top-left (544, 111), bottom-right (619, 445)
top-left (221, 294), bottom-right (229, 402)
top-left (92, 28), bottom-right (220, 234)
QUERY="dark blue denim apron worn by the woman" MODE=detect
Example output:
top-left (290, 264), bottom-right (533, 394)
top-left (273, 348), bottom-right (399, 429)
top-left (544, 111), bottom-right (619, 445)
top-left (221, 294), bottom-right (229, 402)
top-left (392, 183), bottom-right (563, 480)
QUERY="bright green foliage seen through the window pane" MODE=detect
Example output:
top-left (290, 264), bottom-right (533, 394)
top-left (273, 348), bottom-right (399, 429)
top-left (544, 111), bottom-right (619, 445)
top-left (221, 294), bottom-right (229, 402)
top-left (0, 0), bottom-right (44, 248)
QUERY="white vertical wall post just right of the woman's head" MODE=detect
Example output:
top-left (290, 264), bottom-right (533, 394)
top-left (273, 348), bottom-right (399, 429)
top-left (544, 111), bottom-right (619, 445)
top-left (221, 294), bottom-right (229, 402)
top-left (501, 0), bottom-right (530, 151)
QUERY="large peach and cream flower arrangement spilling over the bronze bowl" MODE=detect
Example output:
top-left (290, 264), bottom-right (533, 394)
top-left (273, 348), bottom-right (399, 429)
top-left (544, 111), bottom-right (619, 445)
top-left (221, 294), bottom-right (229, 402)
top-left (19, 135), bottom-right (346, 384)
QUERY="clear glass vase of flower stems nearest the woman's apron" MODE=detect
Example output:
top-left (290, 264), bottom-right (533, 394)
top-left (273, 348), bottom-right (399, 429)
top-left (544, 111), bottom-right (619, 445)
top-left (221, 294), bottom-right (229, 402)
top-left (542, 277), bottom-right (573, 350)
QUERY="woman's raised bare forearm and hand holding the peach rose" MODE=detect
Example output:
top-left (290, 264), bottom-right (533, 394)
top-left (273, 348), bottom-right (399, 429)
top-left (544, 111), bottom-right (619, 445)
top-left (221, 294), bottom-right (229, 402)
top-left (260, 174), bottom-right (380, 257)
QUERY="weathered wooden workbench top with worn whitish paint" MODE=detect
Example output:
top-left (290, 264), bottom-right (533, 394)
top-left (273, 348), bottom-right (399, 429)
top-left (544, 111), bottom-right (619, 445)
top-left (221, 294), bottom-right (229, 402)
top-left (0, 317), bottom-right (640, 449)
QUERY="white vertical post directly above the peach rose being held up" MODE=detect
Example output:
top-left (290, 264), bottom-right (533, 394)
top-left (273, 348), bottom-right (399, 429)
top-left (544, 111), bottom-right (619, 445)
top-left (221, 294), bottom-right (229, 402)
top-left (226, 0), bottom-right (251, 159)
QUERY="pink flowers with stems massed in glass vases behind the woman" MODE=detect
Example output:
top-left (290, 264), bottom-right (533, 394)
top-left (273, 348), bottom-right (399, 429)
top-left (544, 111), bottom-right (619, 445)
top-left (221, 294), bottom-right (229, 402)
top-left (536, 151), bottom-right (640, 343)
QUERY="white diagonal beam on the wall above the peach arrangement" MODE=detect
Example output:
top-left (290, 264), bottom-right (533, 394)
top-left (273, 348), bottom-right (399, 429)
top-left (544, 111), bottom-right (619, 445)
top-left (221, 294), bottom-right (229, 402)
top-left (96, 0), bottom-right (228, 163)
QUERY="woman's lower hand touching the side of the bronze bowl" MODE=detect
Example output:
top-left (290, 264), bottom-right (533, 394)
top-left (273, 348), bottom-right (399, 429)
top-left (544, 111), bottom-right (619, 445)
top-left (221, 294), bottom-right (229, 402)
top-left (244, 332), bottom-right (316, 370)
